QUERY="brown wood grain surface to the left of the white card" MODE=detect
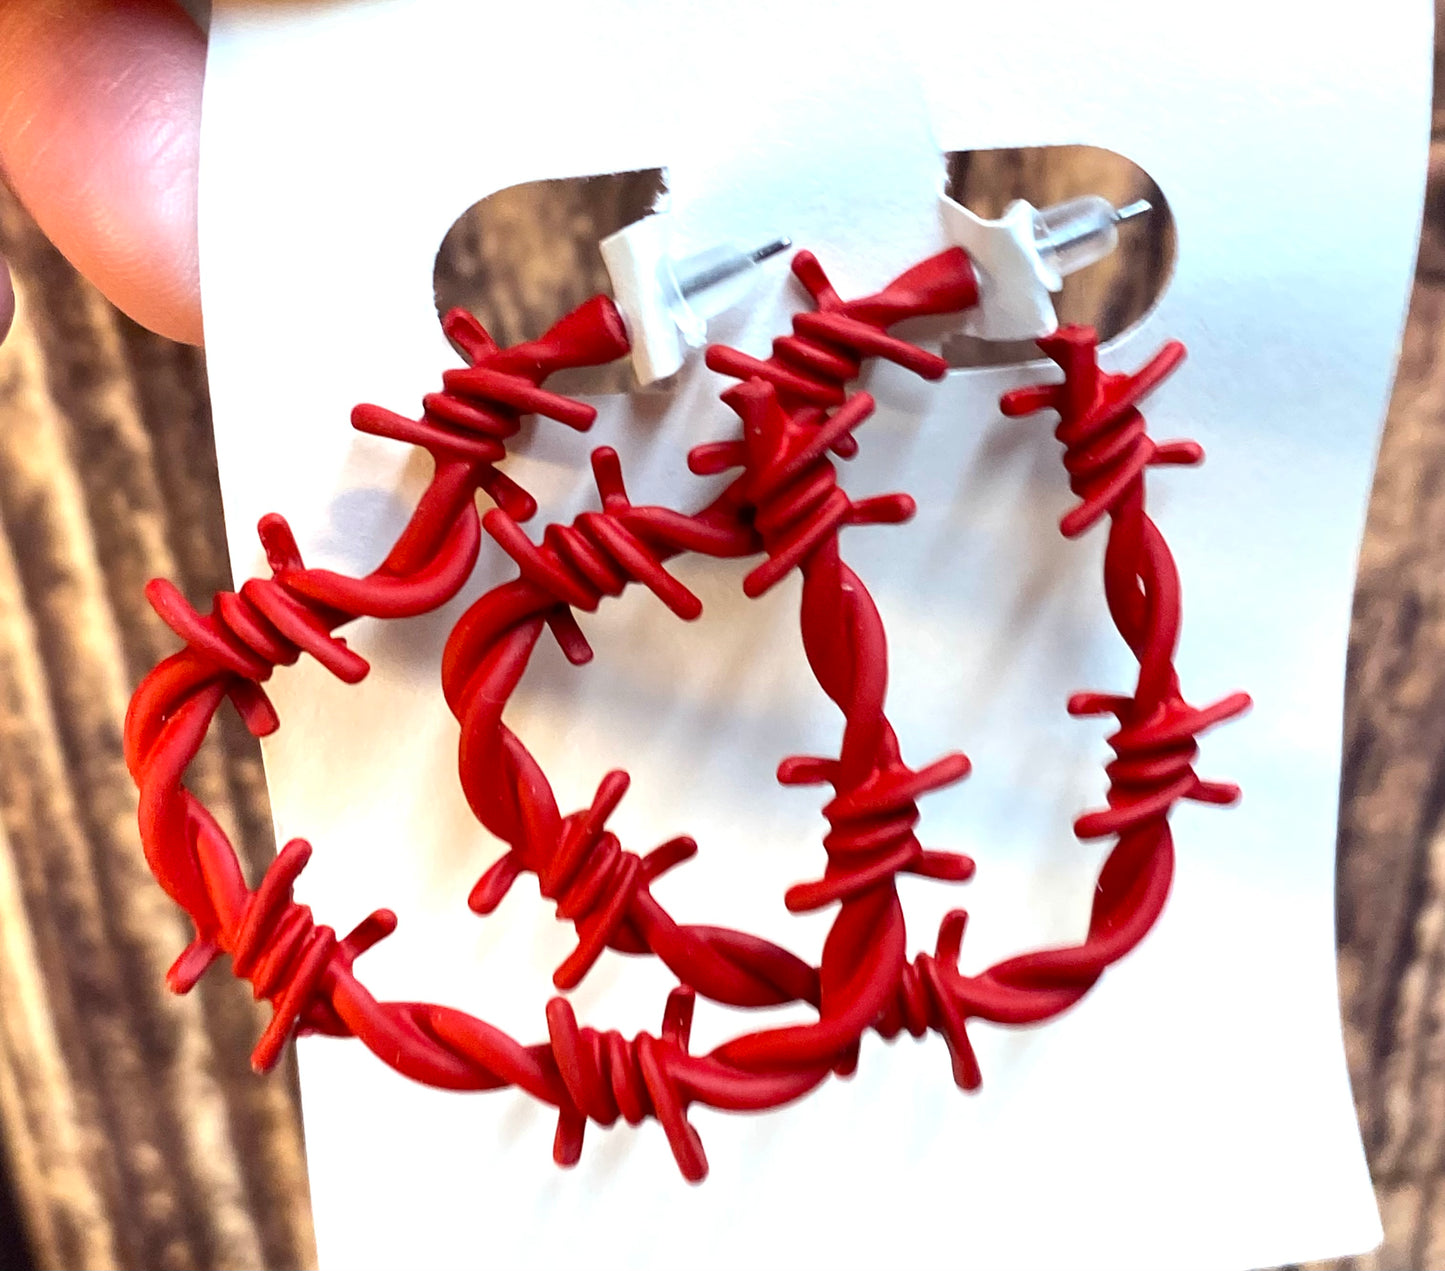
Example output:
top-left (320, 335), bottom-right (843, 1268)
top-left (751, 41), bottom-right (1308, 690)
top-left (0, 181), bottom-right (315, 1267)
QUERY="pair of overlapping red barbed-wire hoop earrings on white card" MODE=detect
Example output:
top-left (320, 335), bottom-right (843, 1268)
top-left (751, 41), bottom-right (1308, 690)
top-left (126, 241), bottom-right (1248, 1180)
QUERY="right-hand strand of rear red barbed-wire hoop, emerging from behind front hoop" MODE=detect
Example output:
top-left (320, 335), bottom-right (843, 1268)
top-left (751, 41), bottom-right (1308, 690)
top-left (879, 326), bottom-right (1250, 1089)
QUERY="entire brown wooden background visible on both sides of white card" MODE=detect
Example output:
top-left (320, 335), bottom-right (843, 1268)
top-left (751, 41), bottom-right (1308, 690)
top-left (0, 34), bottom-right (1445, 1271)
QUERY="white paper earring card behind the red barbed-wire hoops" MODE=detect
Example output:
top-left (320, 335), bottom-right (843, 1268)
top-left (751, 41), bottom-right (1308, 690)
top-left (202, 0), bottom-right (1431, 1268)
